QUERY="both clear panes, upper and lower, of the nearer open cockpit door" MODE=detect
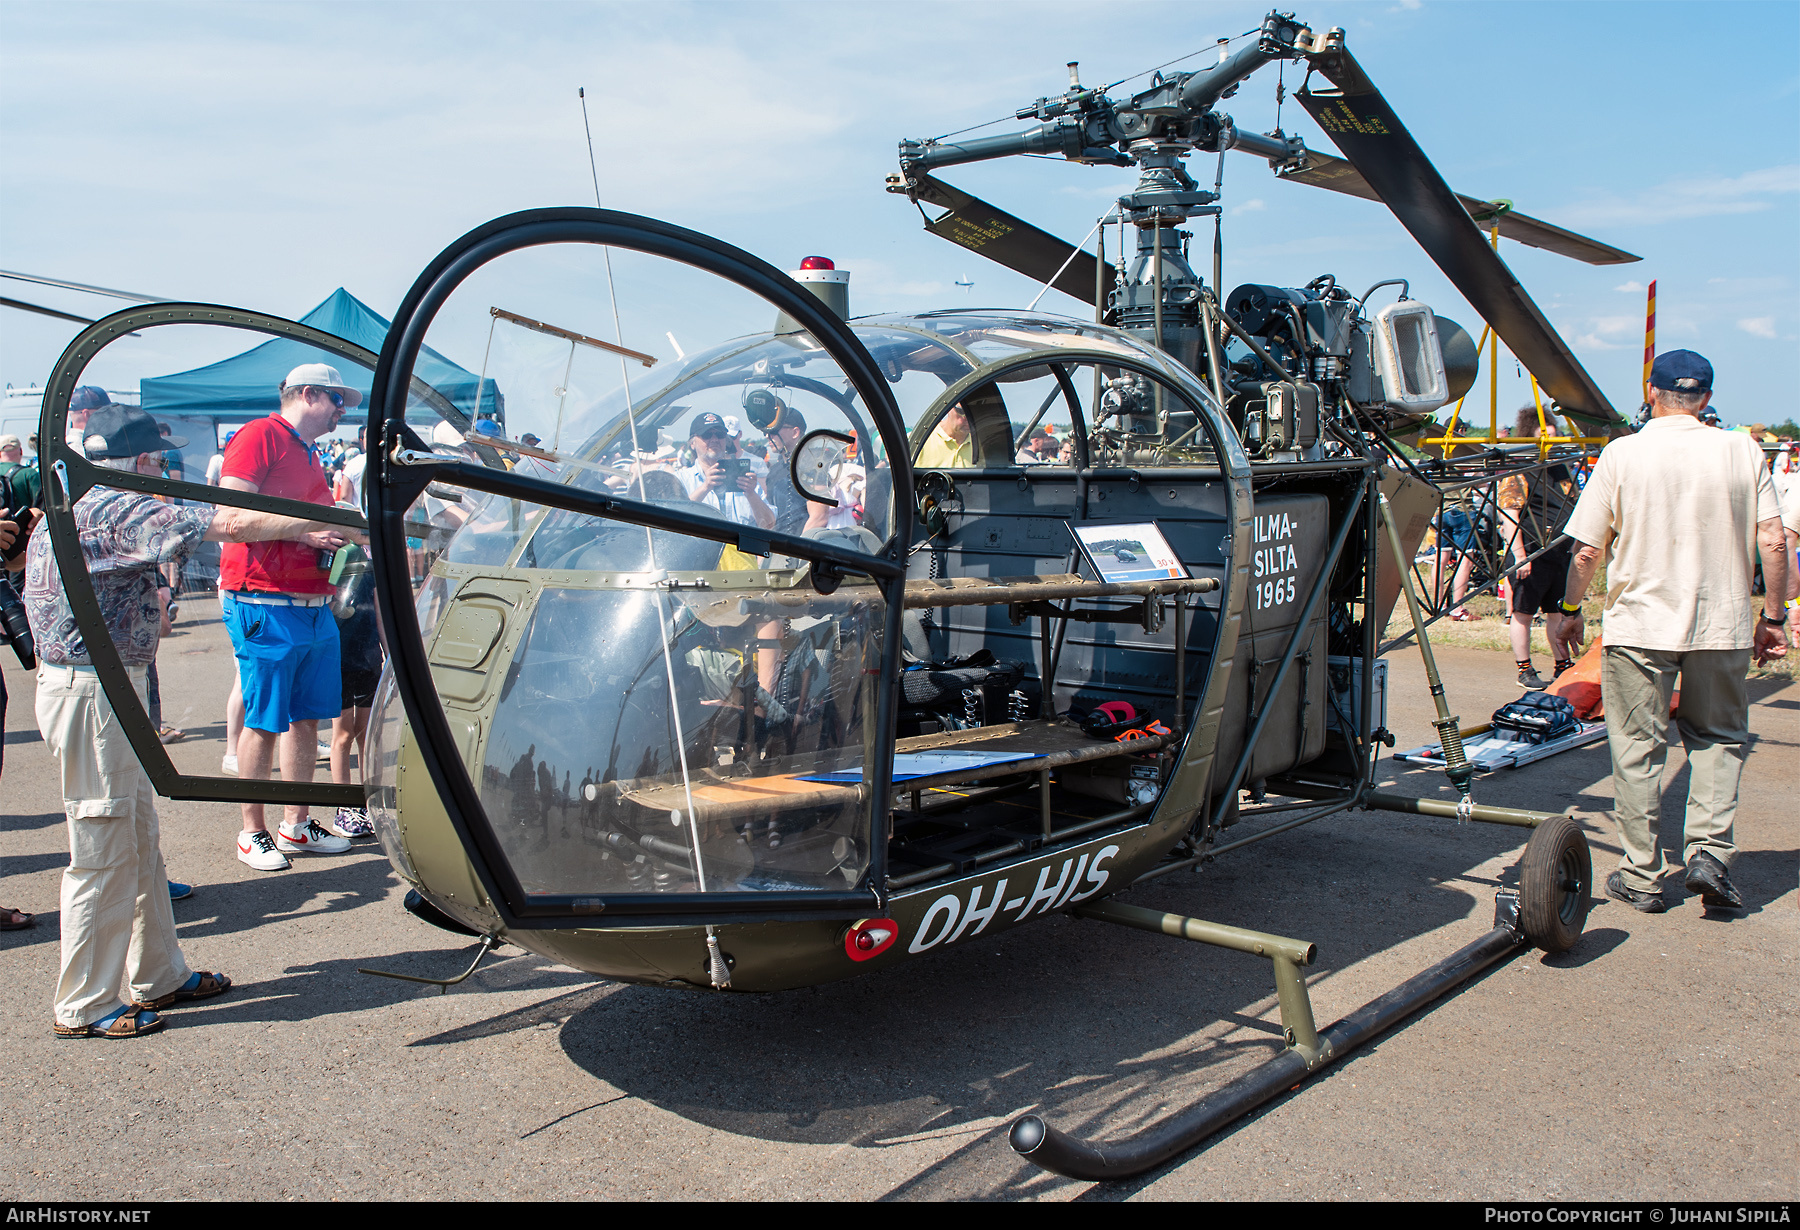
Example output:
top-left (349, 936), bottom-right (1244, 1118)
top-left (371, 245), bottom-right (907, 895)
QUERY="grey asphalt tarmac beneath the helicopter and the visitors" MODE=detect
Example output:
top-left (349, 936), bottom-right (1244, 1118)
top-left (0, 601), bottom-right (1800, 1201)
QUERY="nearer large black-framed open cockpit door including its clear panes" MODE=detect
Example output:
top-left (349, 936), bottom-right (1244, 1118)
top-left (367, 209), bottom-right (913, 929)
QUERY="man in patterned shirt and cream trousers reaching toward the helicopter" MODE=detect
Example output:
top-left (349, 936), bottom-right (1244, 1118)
top-left (25, 405), bottom-right (335, 1037)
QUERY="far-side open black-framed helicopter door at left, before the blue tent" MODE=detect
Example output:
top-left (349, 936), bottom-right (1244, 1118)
top-left (38, 303), bottom-right (435, 807)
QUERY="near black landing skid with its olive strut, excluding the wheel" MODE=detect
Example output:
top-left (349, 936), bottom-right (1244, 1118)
top-left (1010, 891), bottom-right (1525, 1180)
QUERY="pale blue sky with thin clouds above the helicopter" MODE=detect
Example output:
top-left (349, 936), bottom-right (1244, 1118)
top-left (0, 0), bottom-right (1800, 430)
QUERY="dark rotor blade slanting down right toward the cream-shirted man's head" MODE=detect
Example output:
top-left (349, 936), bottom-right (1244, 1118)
top-left (1294, 49), bottom-right (1631, 434)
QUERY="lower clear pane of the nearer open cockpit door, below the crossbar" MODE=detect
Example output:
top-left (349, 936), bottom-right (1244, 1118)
top-left (477, 574), bottom-right (882, 893)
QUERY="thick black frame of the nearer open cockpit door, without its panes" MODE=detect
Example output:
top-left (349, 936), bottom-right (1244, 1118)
top-left (367, 207), bottom-right (913, 929)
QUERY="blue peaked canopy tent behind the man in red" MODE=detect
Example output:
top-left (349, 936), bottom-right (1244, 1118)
top-left (139, 286), bottom-right (506, 423)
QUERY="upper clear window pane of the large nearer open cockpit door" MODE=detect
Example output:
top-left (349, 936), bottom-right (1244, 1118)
top-left (419, 243), bottom-right (907, 547)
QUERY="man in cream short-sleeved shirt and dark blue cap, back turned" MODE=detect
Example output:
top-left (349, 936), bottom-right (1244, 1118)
top-left (1562, 349), bottom-right (1787, 913)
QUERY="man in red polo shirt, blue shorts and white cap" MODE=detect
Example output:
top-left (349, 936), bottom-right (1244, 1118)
top-left (220, 364), bottom-right (362, 872)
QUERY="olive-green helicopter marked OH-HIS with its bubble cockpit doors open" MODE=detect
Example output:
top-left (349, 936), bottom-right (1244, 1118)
top-left (21, 13), bottom-right (1634, 1178)
